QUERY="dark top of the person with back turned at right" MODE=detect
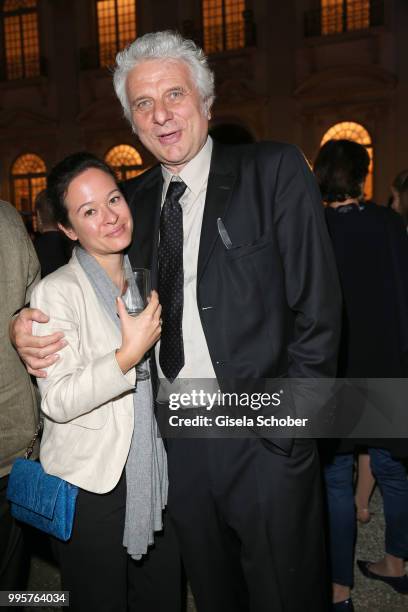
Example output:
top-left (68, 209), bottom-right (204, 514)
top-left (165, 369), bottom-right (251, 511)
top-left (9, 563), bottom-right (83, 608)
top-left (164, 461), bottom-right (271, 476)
top-left (326, 203), bottom-right (408, 455)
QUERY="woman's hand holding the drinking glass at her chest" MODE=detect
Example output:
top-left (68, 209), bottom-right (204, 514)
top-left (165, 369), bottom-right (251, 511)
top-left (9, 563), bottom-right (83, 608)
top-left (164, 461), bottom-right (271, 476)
top-left (116, 291), bottom-right (161, 374)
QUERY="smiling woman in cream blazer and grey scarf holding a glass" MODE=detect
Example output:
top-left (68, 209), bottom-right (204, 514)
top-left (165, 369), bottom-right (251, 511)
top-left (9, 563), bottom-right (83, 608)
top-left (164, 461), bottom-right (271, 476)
top-left (31, 153), bottom-right (180, 612)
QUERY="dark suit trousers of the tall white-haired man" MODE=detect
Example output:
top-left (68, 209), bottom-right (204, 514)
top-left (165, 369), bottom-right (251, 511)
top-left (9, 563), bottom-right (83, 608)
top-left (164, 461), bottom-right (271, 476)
top-left (167, 439), bottom-right (328, 612)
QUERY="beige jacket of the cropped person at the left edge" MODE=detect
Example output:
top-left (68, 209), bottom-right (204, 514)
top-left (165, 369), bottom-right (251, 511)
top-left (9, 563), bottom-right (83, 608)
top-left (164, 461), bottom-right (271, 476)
top-left (0, 200), bottom-right (40, 478)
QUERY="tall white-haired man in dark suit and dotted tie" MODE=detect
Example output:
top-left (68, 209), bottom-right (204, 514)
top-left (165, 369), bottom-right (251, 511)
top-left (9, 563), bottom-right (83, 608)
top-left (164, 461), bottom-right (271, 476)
top-left (10, 32), bottom-right (340, 612)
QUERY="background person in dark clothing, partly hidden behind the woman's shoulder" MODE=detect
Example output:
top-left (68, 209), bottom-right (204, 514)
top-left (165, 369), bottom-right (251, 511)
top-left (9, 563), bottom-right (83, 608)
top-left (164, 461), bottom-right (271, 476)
top-left (34, 189), bottom-right (71, 278)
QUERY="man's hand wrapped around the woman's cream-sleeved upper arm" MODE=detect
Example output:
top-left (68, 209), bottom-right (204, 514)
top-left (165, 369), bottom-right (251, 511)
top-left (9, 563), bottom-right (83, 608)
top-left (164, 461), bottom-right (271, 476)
top-left (10, 308), bottom-right (67, 378)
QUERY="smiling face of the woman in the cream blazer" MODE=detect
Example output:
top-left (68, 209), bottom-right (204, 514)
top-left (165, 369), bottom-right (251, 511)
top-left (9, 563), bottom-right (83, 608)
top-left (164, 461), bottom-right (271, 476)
top-left (60, 168), bottom-right (133, 256)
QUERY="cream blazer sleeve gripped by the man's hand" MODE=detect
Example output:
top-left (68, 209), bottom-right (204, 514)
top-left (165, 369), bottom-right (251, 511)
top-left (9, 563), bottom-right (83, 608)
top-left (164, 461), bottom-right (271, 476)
top-left (31, 277), bottom-right (135, 423)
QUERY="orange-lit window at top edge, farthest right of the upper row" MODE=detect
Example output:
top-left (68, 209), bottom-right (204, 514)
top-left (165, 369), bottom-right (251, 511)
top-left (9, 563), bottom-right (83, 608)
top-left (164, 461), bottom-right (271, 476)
top-left (321, 0), bottom-right (370, 34)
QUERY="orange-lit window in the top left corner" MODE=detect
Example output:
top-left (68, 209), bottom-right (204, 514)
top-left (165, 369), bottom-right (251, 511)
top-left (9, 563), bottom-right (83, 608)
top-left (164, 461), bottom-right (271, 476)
top-left (2, 0), bottom-right (40, 80)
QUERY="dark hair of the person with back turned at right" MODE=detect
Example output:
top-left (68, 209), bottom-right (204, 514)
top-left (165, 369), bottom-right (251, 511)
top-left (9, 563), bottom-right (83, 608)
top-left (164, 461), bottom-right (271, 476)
top-left (314, 140), bottom-right (370, 204)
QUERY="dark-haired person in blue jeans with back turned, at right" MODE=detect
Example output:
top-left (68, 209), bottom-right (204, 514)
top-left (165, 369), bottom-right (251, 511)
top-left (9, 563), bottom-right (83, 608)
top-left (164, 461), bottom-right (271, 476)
top-left (314, 140), bottom-right (408, 612)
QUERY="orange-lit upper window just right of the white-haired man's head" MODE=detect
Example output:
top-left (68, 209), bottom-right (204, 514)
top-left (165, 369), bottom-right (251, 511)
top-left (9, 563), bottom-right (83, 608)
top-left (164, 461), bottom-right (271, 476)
top-left (202, 0), bottom-right (245, 53)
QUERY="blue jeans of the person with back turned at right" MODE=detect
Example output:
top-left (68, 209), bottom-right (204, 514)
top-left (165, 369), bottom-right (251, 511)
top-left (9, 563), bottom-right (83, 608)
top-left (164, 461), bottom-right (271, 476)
top-left (325, 448), bottom-right (408, 587)
